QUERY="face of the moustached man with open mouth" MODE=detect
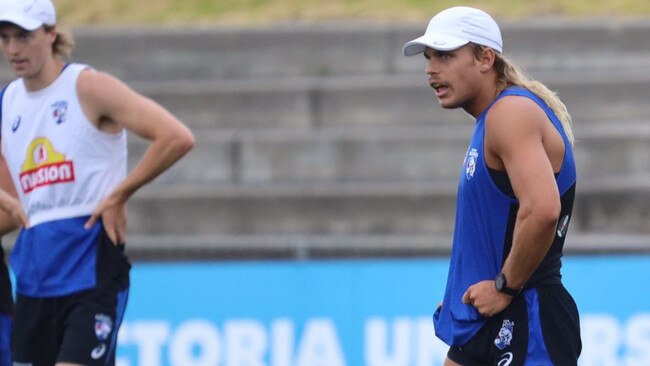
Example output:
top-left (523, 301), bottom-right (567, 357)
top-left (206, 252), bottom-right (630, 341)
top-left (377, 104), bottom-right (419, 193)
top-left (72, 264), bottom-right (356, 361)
top-left (424, 45), bottom-right (481, 108)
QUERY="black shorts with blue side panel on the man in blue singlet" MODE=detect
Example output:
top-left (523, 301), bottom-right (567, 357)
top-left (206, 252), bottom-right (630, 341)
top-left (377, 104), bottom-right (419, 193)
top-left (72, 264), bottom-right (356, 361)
top-left (447, 285), bottom-right (582, 366)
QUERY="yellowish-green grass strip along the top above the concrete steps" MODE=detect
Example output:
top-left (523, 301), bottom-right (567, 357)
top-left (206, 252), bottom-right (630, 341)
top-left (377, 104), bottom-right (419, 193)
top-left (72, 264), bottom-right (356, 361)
top-left (54, 0), bottom-right (650, 26)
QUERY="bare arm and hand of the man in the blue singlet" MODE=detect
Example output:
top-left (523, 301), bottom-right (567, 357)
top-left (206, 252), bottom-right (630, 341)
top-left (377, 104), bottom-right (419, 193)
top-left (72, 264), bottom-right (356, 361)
top-left (465, 97), bottom-right (563, 316)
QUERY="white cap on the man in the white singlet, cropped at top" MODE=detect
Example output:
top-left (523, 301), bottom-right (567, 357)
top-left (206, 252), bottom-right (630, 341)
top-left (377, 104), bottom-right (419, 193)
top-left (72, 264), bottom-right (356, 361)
top-left (0, 0), bottom-right (56, 31)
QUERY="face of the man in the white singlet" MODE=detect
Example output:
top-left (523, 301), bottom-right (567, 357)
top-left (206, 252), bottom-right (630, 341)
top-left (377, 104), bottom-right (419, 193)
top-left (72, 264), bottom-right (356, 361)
top-left (0, 23), bottom-right (56, 78)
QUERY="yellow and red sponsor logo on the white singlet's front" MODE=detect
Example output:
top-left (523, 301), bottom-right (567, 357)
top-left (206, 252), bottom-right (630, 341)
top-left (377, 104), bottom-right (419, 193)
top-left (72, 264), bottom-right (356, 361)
top-left (19, 137), bottom-right (74, 194)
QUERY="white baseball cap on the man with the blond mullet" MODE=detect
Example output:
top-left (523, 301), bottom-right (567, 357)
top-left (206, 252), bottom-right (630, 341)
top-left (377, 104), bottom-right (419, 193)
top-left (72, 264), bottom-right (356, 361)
top-left (402, 6), bottom-right (503, 56)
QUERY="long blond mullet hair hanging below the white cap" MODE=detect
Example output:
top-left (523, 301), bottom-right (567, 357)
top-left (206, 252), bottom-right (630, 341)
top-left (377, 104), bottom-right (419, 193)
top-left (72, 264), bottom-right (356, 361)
top-left (473, 44), bottom-right (575, 145)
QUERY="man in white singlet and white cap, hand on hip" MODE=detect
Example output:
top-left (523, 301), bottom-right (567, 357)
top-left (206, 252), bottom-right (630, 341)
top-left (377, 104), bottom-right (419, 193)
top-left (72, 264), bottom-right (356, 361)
top-left (0, 0), bottom-right (194, 365)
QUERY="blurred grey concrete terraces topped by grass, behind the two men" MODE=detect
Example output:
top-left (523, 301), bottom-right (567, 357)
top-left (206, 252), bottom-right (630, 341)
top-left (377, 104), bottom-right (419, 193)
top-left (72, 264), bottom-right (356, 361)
top-left (0, 0), bottom-right (650, 260)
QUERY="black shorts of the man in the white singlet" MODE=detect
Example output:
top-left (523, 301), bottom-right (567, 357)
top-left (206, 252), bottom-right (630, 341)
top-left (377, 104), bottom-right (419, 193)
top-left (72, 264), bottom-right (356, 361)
top-left (13, 289), bottom-right (128, 366)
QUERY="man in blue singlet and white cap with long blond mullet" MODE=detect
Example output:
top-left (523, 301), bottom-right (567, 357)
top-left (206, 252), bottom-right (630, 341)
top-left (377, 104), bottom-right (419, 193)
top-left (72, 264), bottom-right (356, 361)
top-left (403, 6), bottom-right (582, 366)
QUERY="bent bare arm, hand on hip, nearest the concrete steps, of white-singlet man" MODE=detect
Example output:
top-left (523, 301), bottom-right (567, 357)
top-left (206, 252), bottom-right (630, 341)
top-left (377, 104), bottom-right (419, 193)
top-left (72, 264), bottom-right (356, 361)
top-left (77, 71), bottom-right (194, 243)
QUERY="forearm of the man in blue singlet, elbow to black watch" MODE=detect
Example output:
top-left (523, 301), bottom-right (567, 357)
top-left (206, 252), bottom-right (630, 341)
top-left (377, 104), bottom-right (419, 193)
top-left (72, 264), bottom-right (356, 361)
top-left (502, 209), bottom-right (557, 289)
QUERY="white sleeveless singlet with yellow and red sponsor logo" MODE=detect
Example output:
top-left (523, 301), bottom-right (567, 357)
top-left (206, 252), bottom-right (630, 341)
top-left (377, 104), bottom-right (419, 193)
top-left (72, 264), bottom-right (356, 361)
top-left (0, 64), bottom-right (127, 226)
